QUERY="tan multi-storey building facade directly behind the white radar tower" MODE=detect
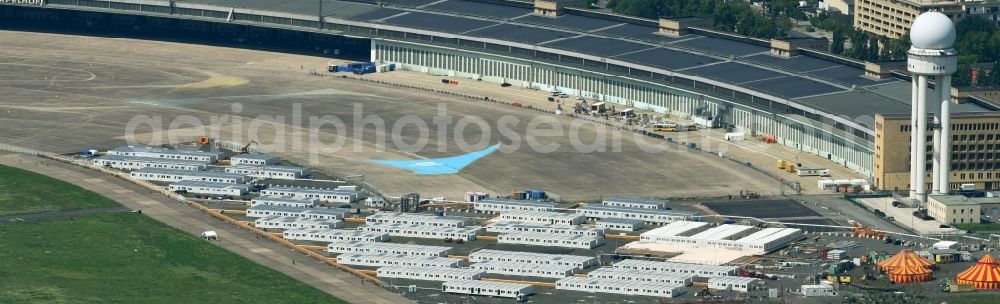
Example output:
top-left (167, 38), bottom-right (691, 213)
top-left (873, 112), bottom-right (1000, 191)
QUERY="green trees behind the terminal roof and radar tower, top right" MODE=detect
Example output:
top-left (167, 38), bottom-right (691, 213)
top-left (607, 0), bottom-right (1000, 86)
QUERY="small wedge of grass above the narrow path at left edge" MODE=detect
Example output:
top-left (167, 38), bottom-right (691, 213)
top-left (0, 166), bottom-right (118, 216)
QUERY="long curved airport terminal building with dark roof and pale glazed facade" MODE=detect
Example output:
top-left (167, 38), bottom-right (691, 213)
top-left (0, 0), bottom-right (997, 185)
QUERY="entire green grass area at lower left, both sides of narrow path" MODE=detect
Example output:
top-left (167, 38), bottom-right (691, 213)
top-left (0, 167), bottom-right (344, 304)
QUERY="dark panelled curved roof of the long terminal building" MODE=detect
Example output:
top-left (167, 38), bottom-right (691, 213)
top-left (35, 0), bottom-right (989, 132)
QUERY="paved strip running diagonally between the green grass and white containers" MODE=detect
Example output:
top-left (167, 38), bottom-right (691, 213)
top-left (0, 154), bottom-right (413, 303)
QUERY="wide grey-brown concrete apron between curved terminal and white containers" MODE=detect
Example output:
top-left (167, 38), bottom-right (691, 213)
top-left (0, 31), bottom-right (778, 201)
